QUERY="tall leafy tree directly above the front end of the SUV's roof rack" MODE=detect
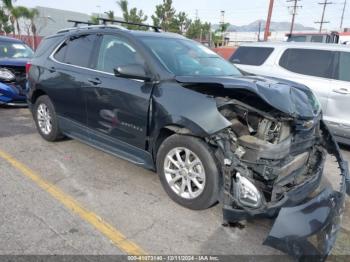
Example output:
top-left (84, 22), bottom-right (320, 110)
top-left (151, 0), bottom-right (179, 32)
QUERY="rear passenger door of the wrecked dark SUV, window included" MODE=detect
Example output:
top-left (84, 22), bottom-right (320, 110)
top-left (45, 34), bottom-right (97, 136)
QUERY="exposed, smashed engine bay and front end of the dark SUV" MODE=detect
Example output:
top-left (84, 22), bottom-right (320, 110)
top-left (211, 97), bottom-right (326, 209)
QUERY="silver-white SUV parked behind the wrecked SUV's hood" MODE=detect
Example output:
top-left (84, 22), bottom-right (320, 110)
top-left (230, 43), bottom-right (350, 145)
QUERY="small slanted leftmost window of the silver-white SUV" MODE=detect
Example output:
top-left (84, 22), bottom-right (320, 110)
top-left (230, 46), bottom-right (273, 66)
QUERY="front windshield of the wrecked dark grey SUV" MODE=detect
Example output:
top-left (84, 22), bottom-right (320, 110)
top-left (141, 37), bottom-right (241, 76)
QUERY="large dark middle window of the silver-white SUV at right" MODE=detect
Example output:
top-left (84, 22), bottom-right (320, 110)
top-left (279, 48), bottom-right (334, 78)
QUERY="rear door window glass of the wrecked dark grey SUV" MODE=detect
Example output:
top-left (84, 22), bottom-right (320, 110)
top-left (54, 35), bottom-right (96, 68)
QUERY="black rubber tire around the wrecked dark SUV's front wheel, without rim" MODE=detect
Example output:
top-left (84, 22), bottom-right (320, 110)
top-left (157, 134), bottom-right (220, 210)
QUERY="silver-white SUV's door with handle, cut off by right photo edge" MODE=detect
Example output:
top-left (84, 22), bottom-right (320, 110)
top-left (326, 52), bottom-right (350, 141)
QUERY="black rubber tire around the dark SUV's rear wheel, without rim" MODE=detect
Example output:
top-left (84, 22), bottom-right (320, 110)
top-left (33, 95), bottom-right (63, 142)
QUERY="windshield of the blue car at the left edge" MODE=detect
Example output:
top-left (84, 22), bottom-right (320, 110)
top-left (0, 42), bottom-right (33, 58)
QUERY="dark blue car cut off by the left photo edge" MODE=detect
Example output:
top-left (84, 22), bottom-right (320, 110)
top-left (0, 36), bottom-right (34, 106)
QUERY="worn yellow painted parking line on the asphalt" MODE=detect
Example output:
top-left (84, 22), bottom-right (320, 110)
top-left (0, 150), bottom-right (146, 255)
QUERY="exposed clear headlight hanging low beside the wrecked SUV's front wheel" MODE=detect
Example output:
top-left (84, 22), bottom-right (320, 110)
top-left (234, 172), bottom-right (261, 208)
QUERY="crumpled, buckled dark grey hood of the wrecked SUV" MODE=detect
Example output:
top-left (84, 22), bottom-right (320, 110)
top-left (175, 76), bottom-right (320, 119)
